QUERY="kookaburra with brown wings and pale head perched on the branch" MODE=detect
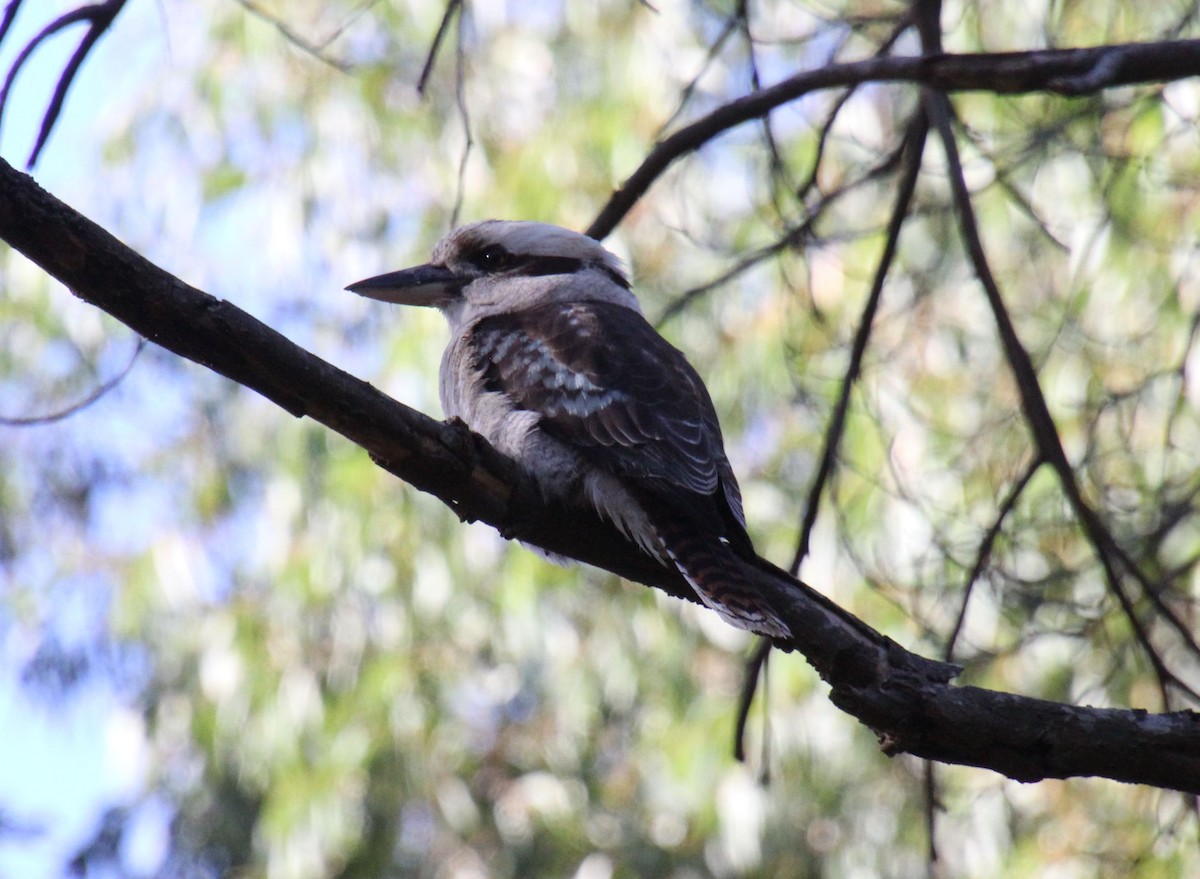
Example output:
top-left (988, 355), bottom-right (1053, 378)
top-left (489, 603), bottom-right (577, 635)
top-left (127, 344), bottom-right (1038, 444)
top-left (348, 220), bottom-right (792, 639)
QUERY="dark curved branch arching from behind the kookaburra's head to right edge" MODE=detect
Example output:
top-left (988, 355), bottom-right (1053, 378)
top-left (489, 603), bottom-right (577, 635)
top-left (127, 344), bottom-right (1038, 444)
top-left (587, 40), bottom-right (1200, 239)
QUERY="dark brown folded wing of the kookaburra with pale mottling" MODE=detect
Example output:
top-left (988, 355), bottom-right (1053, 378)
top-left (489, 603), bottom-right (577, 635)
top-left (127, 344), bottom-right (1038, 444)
top-left (473, 303), bottom-right (745, 537)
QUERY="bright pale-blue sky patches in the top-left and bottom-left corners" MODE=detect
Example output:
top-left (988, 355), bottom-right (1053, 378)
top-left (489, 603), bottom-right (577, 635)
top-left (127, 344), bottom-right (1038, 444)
top-left (0, 0), bottom-right (164, 879)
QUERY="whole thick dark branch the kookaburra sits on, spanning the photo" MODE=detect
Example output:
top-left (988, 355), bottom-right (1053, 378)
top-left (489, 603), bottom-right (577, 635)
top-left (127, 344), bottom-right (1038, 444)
top-left (0, 162), bottom-right (1200, 793)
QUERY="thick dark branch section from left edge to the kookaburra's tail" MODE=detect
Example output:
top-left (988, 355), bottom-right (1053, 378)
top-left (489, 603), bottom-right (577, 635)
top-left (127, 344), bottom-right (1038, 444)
top-left (0, 160), bottom-right (691, 605)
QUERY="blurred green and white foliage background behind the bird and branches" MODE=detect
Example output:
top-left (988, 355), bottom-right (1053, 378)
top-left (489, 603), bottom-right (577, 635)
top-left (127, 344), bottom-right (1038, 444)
top-left (0, 0), bottom-right (1200, 879)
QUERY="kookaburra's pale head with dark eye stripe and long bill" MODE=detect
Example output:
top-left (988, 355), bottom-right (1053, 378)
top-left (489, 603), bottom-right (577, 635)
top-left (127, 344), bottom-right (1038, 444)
top-left (347, 220), bottom-right (641, 325)
